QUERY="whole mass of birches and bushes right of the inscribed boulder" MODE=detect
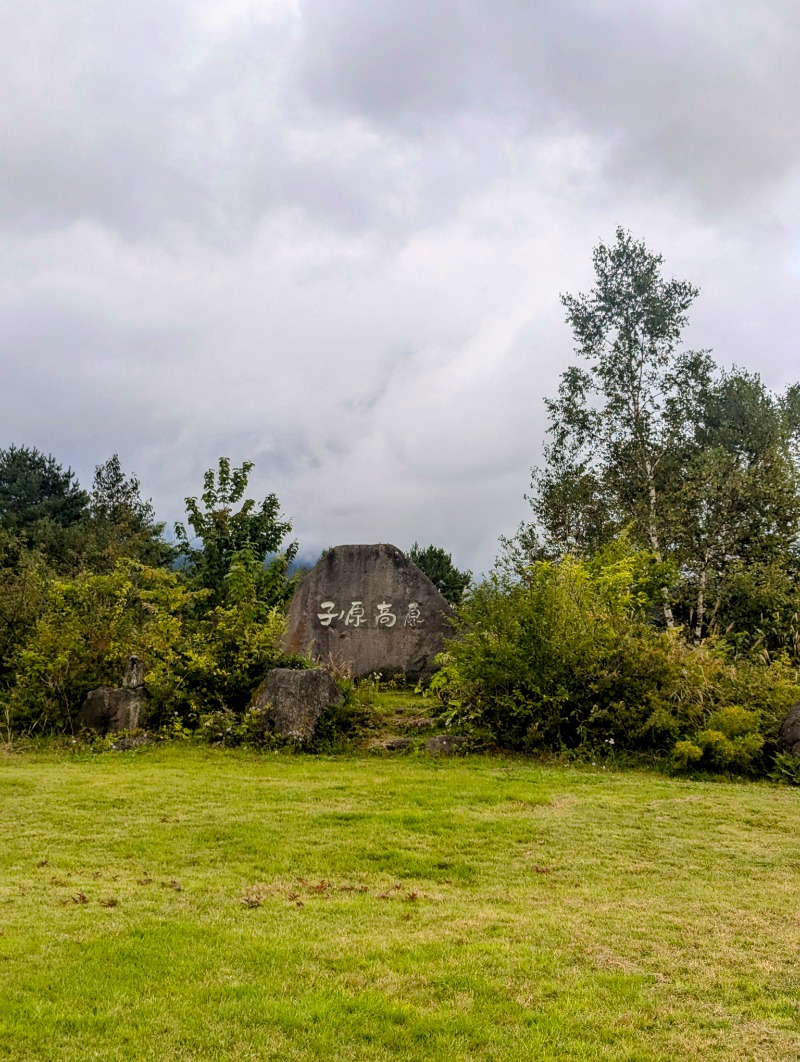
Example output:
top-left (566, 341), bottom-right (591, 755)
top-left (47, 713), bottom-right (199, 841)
top-left (435, 229), bottom-right (800, 780)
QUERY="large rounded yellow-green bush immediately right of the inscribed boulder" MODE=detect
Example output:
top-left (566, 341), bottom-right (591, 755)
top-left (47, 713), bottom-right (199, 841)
top-left (433, 543), bottom-right (680, 749)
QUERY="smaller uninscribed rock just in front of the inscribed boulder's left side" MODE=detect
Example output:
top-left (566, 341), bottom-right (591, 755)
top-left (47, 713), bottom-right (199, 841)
top-left (253, 667), bottom-right (343, 741)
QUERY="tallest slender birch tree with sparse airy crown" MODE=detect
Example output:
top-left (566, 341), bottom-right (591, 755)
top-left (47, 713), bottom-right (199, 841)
top-left (524, 228), bottom-right (713, 626)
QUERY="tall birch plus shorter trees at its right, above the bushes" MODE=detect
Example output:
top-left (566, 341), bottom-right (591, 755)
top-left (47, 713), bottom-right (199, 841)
top-left (524, 228), bottom-right (800, 640)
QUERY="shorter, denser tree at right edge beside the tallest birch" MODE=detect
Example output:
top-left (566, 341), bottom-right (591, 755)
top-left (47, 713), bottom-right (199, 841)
top-left (664, 370), bottom-right (800, 641)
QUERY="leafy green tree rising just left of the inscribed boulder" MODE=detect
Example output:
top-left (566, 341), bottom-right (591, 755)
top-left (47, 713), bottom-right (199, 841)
top-left (175, 458), bottom-right (297, 604)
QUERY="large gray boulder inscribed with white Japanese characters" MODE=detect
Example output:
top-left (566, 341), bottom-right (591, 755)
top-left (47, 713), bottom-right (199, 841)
top-left (285, 543), bottom-right (454, 680)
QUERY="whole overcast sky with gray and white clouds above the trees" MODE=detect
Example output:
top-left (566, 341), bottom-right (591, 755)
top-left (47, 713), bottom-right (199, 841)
top-left (0, 0), bottom-right (800, 570)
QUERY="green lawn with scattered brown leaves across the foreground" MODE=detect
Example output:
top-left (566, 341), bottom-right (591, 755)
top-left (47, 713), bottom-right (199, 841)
top-left (0, 746), bottom-right (800, 1062)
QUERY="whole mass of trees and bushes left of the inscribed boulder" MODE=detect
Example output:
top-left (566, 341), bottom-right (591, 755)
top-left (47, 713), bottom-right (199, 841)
top-left (0, 447), bottom-right (296, 733)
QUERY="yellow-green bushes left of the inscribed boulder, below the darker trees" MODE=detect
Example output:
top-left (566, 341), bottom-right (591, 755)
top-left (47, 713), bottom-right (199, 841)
top-left (7, 551), bottom-right (297, 733)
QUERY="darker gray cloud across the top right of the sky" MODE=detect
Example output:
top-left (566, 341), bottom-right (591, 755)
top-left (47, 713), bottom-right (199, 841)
top-left (301, 0), bottom-right (800, 203)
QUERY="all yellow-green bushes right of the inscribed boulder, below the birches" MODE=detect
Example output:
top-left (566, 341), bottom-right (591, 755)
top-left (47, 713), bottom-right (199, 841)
top-left (431, 539), bottom-right (800, 773)
